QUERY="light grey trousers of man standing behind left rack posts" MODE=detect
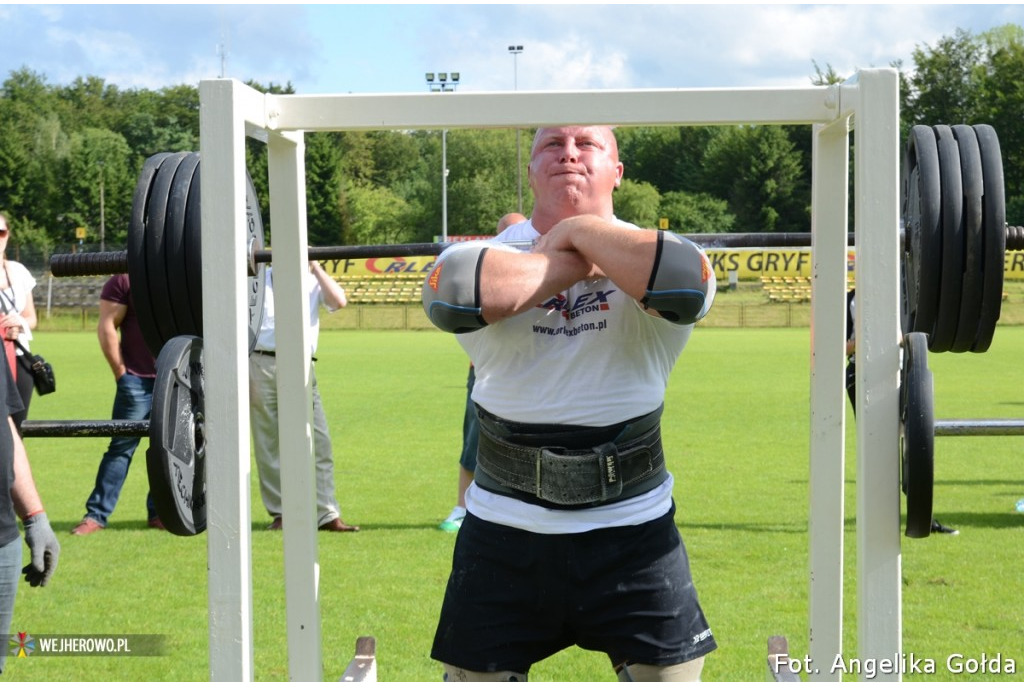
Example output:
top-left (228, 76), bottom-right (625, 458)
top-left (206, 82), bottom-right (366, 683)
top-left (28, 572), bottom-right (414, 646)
top-left (249, 352), bottom-right (341, 526)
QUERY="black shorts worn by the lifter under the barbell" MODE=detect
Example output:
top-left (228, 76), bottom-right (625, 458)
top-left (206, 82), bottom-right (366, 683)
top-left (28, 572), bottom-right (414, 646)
top-left (430, 507), bottom-right (716, 673)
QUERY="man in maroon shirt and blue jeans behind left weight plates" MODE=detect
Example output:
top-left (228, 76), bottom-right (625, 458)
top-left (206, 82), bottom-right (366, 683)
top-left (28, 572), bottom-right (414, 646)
top-left (71, 273), bottom-right (164, 536)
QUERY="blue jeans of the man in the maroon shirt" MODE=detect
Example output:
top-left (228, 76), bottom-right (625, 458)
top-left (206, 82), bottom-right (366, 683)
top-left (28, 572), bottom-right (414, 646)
top-left (85, 374), bottom-right (157, 526)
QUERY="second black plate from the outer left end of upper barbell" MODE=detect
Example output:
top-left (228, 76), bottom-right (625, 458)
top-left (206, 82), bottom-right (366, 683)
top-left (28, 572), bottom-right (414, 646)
top-left (140, 153), bottom-right (187, 356)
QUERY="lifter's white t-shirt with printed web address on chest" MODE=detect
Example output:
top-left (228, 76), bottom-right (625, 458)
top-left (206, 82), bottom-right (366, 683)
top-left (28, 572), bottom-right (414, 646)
top-left (457, 221), bottom-right (715, 533)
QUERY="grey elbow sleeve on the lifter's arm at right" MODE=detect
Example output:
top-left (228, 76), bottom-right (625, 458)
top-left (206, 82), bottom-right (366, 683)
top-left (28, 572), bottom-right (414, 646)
top-left (640, 230), bottom-right (717, 324)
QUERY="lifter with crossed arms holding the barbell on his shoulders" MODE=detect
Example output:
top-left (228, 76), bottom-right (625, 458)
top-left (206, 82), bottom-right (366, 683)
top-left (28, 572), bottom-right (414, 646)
top-left (423, 126), bottom-right (716, 681)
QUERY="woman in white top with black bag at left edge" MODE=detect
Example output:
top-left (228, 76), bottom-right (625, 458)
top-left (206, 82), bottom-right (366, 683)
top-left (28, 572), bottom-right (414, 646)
top-left (0, 214), bottom-right (38, 434)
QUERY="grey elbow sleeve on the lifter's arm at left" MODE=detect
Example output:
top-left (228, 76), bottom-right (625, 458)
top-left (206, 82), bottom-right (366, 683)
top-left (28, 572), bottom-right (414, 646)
top-left (422, 244), bottom-right (487, 333)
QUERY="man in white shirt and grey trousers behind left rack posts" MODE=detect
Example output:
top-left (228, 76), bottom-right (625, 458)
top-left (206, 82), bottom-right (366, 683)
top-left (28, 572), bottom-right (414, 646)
top-left (249, 261), bottom-right (359, 532)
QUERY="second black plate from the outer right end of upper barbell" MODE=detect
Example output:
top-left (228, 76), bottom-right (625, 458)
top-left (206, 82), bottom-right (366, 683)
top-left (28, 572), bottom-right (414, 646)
top-left (949, 124), bottom-right (985, 352)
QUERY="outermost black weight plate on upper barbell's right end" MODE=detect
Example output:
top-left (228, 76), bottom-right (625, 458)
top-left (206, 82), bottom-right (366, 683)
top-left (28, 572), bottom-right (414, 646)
top-left (971, 124), bottom-right (1007, 352)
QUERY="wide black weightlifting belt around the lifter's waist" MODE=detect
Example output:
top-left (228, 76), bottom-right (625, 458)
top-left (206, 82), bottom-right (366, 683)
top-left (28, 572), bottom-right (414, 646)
top-left (474, 405), bottom-right (668, 509)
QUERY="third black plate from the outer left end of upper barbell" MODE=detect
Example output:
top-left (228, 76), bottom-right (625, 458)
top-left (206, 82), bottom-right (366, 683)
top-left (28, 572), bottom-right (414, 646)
top-left (164, 153), bottom-right (202, 336)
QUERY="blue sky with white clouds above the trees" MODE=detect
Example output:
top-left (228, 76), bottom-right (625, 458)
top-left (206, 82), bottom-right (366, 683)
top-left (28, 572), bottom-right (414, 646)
top-left (0, 3), bottom-right (1024, 93)
